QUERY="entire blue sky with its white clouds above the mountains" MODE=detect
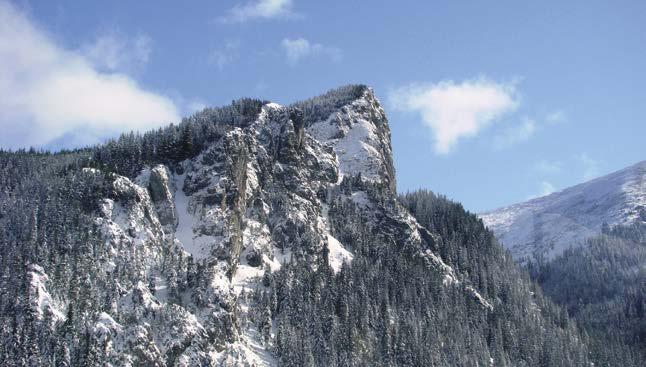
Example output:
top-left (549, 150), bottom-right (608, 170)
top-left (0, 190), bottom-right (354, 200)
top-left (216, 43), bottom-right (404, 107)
top-left (0, 0), bottom-right (646, 212)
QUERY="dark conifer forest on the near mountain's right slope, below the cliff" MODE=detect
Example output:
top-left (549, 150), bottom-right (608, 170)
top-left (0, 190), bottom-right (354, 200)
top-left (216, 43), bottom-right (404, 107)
top-left (259, 190), bottom-right (588, 366)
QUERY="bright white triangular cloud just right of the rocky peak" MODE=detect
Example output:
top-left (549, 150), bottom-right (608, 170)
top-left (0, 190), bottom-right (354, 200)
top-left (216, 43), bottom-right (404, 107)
top-left (390, 78), bottom-right (518, 154)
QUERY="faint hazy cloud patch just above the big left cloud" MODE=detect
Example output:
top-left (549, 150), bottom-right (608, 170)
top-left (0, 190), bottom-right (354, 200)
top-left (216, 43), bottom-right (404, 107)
top-left (81, 30), bottom-right (152, 72)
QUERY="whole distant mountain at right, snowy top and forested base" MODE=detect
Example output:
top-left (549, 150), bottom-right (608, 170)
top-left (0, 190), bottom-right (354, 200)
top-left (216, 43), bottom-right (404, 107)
top-left (480, 161), bottom-right (646, 366)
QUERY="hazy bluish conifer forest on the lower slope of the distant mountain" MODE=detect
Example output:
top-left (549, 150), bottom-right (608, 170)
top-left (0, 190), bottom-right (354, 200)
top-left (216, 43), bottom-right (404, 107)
top-left (527, 223), bottom-right (646, 366)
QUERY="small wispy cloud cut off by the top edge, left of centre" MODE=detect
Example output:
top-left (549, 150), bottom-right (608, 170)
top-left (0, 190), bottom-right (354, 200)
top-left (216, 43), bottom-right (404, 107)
top-left (218, 0), bottom-right (298, 23)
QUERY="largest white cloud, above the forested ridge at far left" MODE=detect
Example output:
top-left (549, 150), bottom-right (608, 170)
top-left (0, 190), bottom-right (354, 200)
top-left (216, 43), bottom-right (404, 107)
top-left (0, 2), bottom-right (179, 148)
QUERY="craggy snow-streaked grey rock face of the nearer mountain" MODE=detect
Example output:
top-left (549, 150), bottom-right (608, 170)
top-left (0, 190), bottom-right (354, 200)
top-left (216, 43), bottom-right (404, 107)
top-left (111, 88), bottom-right (460, 365)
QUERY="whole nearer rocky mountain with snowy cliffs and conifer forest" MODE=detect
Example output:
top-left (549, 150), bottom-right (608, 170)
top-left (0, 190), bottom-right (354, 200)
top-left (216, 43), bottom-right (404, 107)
top-left (0, 85), bottom-right (590, 366)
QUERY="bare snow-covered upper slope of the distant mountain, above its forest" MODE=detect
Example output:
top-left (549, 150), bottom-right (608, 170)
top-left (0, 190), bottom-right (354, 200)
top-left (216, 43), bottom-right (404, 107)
top-left (480, 161), bottom-right (646, 259)
